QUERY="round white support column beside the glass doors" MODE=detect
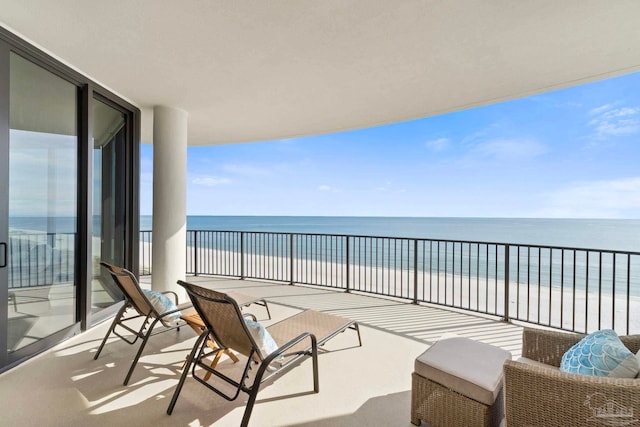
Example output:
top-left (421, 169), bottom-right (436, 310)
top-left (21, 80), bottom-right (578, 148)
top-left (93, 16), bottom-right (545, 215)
top-left (151, 106), bottom-right (188, 297)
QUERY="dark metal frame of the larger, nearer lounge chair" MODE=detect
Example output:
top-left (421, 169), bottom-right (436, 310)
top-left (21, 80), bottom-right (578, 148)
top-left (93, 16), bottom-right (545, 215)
top-left (167, 281), bottom-right (362, 427)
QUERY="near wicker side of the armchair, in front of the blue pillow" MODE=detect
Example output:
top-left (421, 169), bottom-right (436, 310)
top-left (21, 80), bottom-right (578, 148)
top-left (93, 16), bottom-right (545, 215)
top-left (504, 361), bottom-right (640, 427)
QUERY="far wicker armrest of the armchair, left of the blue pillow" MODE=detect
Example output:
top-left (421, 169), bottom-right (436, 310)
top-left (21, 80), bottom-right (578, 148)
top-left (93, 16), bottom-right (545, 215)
top-left (522, 328), bottom-right (584, 367)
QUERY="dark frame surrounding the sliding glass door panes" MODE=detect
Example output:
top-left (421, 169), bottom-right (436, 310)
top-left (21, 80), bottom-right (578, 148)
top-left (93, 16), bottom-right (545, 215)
top-left (0, 27), bottom-right (141, 372)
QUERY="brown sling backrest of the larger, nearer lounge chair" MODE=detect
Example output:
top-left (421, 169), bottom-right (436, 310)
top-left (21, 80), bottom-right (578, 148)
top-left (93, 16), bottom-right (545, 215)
top-left (178, 280), bottom-right (260, 357)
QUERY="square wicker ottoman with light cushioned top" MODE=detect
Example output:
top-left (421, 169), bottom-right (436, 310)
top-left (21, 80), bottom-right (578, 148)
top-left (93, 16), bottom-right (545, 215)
top-left (411, 337), bottom-right (511, 427)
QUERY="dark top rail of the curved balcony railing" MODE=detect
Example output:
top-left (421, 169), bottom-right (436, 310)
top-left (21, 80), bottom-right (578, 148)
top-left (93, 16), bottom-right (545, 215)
top-left (141, 230), bottom-right (640, 256)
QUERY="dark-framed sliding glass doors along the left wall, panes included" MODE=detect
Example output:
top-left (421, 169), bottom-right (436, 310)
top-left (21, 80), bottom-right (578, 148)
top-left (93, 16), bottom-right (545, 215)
top-left (0, 27), bottom-right (140, 372)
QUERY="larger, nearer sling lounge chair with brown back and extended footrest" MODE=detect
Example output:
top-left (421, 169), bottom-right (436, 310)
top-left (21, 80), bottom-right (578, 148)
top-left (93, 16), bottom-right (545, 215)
top-left (167, 281), bottom-right (362, 427)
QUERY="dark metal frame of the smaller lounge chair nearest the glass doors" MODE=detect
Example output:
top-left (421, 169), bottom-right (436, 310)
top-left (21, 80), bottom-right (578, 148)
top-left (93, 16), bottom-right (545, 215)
top-left (93, 262), bottom-right (191, 385)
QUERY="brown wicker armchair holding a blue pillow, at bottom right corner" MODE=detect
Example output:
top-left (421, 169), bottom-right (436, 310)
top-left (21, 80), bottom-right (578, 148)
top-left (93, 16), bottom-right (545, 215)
top-left (504, 329), bottom-right (640, 427)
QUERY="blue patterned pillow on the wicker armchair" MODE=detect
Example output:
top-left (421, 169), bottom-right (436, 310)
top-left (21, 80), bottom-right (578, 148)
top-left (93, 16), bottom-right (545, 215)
top-left (560, 329), bottom-right (640, 378)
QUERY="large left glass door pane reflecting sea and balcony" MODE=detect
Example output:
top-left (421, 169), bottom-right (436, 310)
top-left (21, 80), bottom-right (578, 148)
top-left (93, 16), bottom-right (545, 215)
top-left (6, 53), bottom-right (78, 353)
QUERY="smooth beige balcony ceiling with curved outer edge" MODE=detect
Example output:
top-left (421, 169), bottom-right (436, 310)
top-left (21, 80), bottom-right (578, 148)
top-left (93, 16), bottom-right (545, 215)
top-left (0, 0), bottom-right (640, 145)
